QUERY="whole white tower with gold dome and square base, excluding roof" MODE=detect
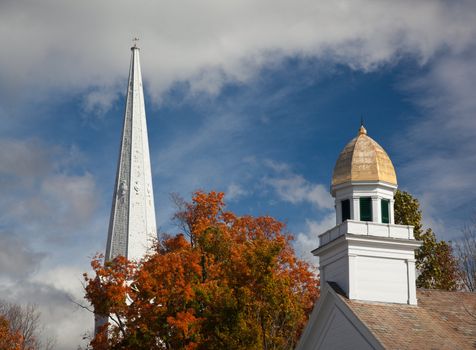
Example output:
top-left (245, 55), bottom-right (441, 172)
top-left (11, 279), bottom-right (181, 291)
top-left (313, 125), bottom-right (421, 305)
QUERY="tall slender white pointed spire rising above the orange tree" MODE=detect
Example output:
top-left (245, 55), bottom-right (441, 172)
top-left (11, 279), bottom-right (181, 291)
top-left (106, 40), bottom-right (157, 260)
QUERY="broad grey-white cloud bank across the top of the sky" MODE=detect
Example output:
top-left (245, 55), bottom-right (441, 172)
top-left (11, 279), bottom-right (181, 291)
top-left (0, 0), bottom-right (476, 108)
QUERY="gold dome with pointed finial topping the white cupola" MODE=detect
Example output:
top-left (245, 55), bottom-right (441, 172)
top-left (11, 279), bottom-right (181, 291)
top-left (332, 125), bottom-right (397, 187)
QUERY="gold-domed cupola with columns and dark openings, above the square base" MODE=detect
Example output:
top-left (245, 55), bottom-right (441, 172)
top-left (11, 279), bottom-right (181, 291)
top-left (331, 125), bottom-right (397, 224)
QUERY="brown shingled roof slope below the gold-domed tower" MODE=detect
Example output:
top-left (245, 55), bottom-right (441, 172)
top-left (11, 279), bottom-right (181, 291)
top-left (331, 283), bottom-right (476, 350)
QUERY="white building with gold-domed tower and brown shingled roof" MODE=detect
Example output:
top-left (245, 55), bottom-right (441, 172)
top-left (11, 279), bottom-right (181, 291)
top-left (297, 125), bottom-right (476, 350)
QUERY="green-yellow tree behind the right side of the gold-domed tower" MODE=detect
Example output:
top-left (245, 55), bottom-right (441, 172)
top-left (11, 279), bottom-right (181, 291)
top-left (395, 190), bottom-right (458, 290)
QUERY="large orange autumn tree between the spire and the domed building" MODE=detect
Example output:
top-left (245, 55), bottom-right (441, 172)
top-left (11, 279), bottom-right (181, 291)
top-left (85, 192), bottom-right (318, 350)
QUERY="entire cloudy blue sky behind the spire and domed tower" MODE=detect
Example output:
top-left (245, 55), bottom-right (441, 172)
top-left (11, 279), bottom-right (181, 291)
top-left (0, 0), bottom-right (476, 349)
